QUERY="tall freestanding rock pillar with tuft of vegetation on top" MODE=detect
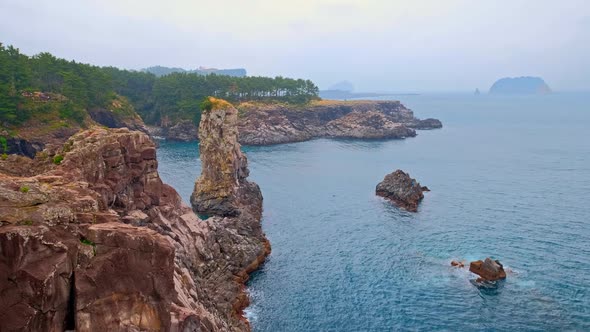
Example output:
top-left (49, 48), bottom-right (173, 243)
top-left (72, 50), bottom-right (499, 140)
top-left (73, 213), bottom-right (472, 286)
top-left (191, 97), bottom-right (262, 217)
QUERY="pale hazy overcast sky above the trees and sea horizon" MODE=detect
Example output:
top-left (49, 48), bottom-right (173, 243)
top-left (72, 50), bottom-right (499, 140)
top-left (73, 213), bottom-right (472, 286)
top-left (0, 0), bottom-right (590, 92)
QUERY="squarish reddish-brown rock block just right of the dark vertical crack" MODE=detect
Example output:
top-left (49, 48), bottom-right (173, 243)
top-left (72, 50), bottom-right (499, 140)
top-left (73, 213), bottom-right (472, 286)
top-left (75, 223), bottom-right (175, 332)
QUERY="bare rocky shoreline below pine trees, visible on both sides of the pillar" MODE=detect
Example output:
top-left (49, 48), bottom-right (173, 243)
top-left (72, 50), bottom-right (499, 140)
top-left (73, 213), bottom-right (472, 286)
top-left (0, 100), bottom-right (442, 158)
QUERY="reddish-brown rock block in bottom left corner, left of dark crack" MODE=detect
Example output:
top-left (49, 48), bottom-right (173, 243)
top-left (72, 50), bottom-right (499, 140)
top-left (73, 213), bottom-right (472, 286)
top-left (0, 226), bottom-right (77, 331)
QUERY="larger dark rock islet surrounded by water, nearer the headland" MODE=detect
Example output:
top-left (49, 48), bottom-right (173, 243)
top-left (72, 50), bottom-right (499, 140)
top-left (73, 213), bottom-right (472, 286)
top-left (375, 169), bottom-right (430, 212)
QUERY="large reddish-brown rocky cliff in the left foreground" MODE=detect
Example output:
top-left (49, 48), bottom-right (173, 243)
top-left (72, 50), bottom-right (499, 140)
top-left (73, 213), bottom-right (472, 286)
top-left (0, 124), bottom-right (270, 331)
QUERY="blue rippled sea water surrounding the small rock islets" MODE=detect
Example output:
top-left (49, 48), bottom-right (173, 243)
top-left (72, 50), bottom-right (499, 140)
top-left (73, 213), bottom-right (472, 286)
top-left (158, 94), bottom-right (590, 331)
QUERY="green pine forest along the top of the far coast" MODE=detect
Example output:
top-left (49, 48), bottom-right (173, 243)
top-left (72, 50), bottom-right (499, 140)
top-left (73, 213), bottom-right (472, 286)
top-left (0, 43), bottom-right (319, 126)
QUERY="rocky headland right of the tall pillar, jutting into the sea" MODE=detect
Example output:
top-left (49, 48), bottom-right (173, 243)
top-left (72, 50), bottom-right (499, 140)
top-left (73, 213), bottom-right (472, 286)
top-left (238, 100), bottom-right (442, 145)
